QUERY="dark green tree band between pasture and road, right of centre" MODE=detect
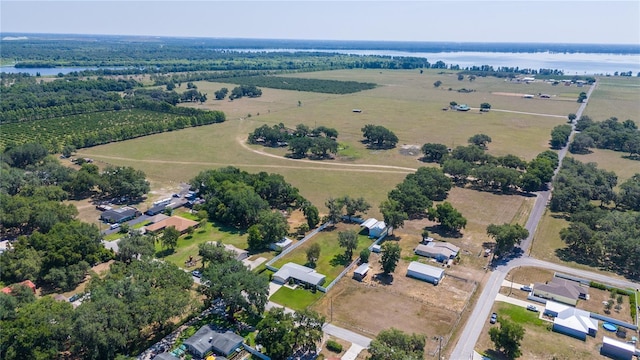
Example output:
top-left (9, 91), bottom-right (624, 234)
top-left (422, 134), bottom-right (558, 192)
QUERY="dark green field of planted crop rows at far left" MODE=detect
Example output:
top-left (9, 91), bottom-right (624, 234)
top-left (0, 109), bottom-right (224, 151)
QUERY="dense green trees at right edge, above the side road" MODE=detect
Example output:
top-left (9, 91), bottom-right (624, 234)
top-left (549, 158), bottom-right (640, 280)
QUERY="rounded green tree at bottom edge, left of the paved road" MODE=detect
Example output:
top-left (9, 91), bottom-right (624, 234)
top-left (369, 328), bottom-right (425, 360)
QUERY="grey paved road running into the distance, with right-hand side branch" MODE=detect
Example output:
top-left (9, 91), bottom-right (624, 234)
top-left (450, 83), bottom-right (640, 360)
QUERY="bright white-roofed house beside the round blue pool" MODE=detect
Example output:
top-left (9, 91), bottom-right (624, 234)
top-left (544, 301), bottom-right (598, 341)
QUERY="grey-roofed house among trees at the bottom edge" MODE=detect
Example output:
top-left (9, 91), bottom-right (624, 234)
top-left (184, 325), bottom-right (244, 358)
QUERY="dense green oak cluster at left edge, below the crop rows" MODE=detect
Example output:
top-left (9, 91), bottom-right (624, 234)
top-left (0, 144), bottom-right (149, 291)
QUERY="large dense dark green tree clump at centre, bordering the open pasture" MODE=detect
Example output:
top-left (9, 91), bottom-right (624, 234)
top-left (190, 167), bottom-right (320, 250)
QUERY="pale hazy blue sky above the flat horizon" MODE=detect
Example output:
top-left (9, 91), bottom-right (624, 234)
top-left (0, 0), bottom-right (640, 44)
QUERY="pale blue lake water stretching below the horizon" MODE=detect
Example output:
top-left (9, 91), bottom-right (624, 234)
top-left (0, 49), bottom-right (640, 76)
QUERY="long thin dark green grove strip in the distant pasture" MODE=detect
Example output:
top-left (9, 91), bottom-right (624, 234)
top-left (216, 76), bottom-right (376, 94)
